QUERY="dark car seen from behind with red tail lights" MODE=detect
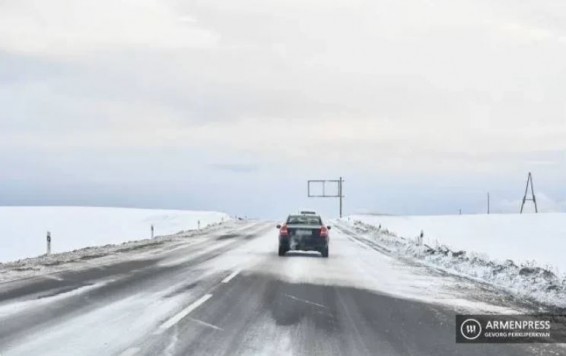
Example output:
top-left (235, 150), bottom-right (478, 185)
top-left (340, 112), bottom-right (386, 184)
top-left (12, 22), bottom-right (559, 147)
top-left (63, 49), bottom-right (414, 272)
top-left (277, 214), bottom-right (330, 257)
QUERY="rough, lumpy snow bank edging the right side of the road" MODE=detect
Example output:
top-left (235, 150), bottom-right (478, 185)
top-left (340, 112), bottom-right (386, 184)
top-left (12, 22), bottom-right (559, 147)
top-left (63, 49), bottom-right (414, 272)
top-left (341, 220), bottom-right (566, 308)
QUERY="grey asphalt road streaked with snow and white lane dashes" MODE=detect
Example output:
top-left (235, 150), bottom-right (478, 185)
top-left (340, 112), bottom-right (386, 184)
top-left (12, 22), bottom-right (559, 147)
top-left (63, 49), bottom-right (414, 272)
top-left (0, 223), bottom-right (566, 356)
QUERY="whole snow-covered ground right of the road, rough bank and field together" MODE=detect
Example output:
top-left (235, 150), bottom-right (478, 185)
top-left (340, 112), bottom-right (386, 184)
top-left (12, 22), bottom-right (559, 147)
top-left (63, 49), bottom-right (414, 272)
top-left (342, 213), bottom-right (566, 308)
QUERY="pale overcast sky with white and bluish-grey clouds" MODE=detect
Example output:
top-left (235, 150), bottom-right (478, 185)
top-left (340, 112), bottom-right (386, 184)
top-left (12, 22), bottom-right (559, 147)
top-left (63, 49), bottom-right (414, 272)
top-left (0, 0), bottom-right (566, 217)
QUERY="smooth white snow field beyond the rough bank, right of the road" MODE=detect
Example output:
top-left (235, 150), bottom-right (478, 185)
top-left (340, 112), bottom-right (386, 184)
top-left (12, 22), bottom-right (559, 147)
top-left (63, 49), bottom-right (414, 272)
top-left (345, 213), bottom-right (566, 273)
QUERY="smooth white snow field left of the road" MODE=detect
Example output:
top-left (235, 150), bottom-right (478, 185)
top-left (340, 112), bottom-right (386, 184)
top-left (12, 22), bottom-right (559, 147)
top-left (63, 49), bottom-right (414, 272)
top-left (0, 207), bottom-right (230, 262)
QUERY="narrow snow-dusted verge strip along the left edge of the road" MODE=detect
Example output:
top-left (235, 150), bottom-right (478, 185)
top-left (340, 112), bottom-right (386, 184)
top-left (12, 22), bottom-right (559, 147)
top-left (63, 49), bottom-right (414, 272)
top-left (0, 220), bottom-right (238, 282)
